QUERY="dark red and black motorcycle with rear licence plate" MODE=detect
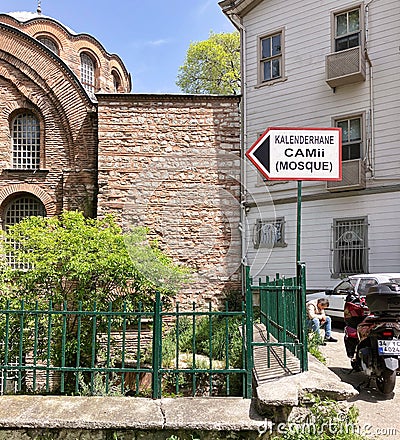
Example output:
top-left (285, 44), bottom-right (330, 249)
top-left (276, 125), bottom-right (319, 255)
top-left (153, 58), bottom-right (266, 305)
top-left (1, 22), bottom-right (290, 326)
top-left (344, 283), bottom-right (400, 394)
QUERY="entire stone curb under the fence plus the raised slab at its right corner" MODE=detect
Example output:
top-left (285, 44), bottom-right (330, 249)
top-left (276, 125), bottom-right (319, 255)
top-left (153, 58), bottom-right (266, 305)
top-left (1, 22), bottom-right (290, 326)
top-left (0, 356), bottom-right (358, 432)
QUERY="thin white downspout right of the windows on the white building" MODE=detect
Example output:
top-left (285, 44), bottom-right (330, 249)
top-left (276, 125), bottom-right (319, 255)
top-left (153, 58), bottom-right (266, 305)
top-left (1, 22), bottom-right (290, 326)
top-left (364, 0), bottom-right (375, 178)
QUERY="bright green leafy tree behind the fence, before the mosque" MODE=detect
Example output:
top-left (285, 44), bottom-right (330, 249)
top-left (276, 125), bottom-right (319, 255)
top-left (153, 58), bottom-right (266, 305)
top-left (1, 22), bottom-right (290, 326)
top-left (0, 211), bottom-right (189, 384)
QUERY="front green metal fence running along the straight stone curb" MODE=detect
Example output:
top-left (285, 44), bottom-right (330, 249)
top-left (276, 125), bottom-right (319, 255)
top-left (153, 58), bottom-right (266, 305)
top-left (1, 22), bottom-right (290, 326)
top-left (0, 294), bottom-right (251, 398)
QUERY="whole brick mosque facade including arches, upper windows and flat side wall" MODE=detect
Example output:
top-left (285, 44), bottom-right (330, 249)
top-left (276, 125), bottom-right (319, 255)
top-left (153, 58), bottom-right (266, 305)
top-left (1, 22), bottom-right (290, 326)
top-left (0, 13), bottom-right (241, 303)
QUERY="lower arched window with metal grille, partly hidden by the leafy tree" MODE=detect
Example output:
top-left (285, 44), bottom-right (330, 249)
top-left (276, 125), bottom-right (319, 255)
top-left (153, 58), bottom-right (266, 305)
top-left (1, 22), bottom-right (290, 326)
top-left (3, 194), bottom-right (46, 269)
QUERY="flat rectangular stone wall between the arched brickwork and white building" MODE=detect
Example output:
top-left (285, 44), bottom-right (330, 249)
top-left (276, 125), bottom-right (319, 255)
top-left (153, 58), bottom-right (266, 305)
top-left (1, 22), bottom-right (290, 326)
top-left (97, 95), bottom-right (240, 303)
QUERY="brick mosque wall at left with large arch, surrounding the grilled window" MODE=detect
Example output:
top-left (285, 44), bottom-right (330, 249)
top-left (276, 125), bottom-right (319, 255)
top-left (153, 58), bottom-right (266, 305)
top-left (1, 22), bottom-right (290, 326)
top-left (0, 27), bottom-right (97, 215)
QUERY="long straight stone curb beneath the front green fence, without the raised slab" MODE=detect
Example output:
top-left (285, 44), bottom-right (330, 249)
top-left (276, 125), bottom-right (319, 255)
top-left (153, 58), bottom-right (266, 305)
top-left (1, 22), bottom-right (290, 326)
top-left (0, 396), bottom-right (264, 431)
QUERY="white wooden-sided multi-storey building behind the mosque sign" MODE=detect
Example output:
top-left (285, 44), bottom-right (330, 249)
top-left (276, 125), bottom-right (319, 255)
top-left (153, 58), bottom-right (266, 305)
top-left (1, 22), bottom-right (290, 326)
top-left (219, 0), bottom-right (400, 290)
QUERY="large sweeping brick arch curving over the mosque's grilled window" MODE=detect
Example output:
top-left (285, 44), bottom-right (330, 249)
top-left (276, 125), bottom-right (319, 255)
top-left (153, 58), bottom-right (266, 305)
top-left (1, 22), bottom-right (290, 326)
top-left (0, 23), bottom-right (97, 168)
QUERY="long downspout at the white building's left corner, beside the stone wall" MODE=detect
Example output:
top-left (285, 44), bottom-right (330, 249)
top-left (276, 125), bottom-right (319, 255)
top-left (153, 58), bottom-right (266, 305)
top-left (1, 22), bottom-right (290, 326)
top-left (227, 13), bottom-right (247, 291)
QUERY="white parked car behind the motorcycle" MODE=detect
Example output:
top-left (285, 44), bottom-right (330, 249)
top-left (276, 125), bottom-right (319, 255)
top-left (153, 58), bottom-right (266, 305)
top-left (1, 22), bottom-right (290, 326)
top-left (306, 273), bottom-right (400, 319)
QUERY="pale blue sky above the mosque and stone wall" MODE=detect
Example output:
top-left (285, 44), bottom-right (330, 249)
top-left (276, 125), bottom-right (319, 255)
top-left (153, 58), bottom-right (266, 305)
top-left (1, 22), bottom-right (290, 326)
top-left (0, 0), bottom-right (235, 93)
